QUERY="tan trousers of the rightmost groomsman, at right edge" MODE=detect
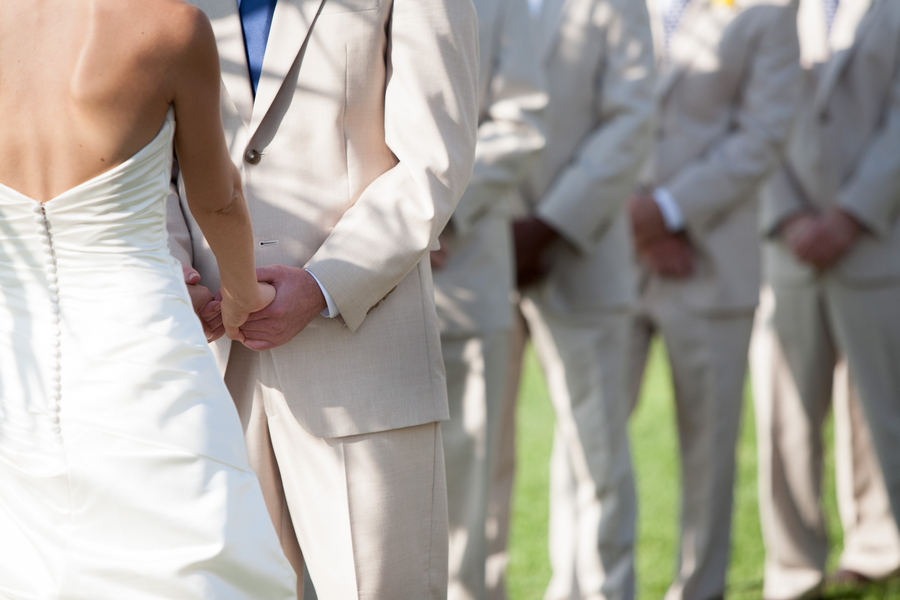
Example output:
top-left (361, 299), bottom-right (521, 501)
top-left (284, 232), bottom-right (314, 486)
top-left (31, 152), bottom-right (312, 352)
top-left (751, 281), bottom-right (900, 600)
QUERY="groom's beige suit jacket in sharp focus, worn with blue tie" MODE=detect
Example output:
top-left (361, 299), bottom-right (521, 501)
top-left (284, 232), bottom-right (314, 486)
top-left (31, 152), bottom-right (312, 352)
top-left (169, 0), bottom-right (478, 437)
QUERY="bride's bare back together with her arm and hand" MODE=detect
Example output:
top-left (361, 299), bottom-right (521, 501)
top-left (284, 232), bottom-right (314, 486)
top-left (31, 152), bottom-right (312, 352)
top-left (0, 0), bottom-right (275, 340)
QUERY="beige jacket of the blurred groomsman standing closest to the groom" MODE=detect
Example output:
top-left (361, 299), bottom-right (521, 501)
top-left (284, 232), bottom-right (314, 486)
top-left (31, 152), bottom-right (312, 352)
top-left (434, 0), bottom-right (547, 335)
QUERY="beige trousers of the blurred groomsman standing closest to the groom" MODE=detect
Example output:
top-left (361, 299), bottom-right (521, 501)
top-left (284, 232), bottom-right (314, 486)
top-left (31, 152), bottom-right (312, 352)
top-left (441, 331), bottom-right (509, 600)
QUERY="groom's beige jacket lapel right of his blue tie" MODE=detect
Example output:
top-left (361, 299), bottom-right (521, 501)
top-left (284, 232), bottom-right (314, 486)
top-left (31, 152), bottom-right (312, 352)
top-left (250, 0), bottom-right (324, 137)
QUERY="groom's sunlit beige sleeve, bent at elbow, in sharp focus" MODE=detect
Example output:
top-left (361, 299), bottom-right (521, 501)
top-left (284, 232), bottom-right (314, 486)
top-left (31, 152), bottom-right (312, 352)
top-left (306, 0), bottom-right (478, 331)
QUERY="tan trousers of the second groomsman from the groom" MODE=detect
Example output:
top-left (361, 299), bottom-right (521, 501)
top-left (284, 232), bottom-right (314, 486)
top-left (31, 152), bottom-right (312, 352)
top-left (488, 296), bottom-right (636, 600)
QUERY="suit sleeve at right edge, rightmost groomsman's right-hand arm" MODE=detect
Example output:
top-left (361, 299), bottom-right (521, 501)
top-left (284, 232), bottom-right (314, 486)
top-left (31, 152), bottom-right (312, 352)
top-left (838, 33), bottom-right (900, 237)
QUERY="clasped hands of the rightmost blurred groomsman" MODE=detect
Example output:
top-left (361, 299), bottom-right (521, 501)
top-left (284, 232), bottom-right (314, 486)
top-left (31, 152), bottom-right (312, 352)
top-left (779, 208), bottom-right (862, 270)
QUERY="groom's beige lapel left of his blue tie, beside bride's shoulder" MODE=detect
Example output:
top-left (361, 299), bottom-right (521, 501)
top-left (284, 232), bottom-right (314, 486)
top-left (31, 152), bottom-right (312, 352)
top-left (191, 0), bottom-right (253, 125)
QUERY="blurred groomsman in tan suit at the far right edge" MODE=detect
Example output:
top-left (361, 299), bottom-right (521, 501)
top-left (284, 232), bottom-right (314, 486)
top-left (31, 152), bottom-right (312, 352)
top-left (753, 0), bottom-right (900, 600)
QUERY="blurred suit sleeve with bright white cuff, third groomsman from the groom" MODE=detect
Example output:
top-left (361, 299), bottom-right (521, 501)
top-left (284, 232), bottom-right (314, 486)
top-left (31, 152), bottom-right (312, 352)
top-left (665, 5), bottom-right (800, 237)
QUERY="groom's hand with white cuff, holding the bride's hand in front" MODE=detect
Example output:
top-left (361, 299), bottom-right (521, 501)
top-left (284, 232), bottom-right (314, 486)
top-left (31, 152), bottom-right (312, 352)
top-left (241, 265), bottom-right (327, 350)
